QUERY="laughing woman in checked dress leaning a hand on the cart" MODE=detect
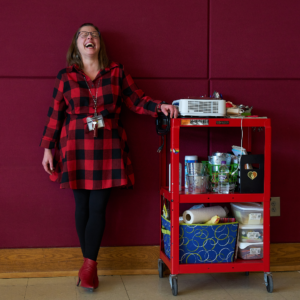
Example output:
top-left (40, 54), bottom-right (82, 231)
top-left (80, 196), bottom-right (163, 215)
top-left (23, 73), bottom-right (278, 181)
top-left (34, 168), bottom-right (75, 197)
top-left (40, 23), bottom-right (178, 291)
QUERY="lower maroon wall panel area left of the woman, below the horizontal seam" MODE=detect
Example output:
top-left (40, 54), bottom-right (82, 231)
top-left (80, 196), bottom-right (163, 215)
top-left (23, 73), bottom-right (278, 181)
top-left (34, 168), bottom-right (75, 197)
top-left (0, 79), bottom-right (77, 247)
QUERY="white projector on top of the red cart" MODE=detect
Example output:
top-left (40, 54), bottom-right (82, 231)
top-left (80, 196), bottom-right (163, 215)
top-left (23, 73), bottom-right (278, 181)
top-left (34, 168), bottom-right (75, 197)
top-left (172, 98), bottom-right (226, 117)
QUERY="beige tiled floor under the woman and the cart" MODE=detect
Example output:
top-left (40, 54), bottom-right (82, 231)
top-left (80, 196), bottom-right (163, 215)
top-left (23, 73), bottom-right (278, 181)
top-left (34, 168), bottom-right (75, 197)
top-left (0, 272), bottom-right (300, 300)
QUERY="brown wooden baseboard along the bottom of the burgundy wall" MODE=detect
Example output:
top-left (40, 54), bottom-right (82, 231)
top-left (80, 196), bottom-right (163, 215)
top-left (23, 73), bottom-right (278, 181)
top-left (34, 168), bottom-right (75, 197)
top-left (0, 243), bottom-right (300, 278)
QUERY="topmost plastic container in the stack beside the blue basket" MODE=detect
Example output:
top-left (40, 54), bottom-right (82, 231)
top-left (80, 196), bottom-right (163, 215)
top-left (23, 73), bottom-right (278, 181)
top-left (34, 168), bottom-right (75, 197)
top-left (230, 202), bottom-right (264, 225)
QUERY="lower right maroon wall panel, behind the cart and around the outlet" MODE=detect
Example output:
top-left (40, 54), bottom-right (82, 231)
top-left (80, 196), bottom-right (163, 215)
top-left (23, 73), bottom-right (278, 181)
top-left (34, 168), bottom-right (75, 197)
top-left (211, 80), bottom-right (300, 243)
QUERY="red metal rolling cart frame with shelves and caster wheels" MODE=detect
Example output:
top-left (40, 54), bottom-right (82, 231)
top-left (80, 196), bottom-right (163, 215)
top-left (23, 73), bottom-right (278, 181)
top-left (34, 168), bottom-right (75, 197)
top-left (158, 118), bottom-right (273, 296)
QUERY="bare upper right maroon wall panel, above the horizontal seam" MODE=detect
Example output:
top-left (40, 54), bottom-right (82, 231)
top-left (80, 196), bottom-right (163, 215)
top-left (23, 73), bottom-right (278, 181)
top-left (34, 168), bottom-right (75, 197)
top-left (210, 0), bottom-right (300, 79)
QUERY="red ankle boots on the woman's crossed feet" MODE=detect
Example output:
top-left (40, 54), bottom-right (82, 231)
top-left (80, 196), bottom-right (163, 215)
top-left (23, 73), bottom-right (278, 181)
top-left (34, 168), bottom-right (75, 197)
top-left (77, 258), bottom-right (99, 292)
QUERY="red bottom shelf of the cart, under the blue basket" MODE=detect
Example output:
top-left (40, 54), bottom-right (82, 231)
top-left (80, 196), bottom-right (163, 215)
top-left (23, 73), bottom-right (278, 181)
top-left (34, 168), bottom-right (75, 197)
top-left (160, 252), bottom-right (270, 274)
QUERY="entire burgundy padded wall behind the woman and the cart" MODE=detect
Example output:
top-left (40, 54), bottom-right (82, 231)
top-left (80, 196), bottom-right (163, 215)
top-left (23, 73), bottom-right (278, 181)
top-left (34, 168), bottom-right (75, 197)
top-left (0, 0), bottom-right (300, 248)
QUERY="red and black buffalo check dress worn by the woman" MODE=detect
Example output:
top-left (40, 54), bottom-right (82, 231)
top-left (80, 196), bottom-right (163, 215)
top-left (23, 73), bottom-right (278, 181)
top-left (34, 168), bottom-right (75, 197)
top-left (40, 62), bottom-right (161, 190)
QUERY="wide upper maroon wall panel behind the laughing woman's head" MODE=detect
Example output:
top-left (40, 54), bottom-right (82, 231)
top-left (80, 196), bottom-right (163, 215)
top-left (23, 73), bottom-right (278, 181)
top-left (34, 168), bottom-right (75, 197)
top-left (0, 0), bottom-right (208, 78)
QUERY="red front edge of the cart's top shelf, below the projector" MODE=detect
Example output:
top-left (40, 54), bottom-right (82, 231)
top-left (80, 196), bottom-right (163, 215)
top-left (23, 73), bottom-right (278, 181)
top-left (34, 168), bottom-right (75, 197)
top-left (171, 117), bottom-right (271, 127)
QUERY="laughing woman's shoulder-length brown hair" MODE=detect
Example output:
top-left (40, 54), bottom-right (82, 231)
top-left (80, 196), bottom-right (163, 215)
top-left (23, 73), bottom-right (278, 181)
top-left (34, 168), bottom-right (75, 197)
top-left (67, 23), bottom-right (109, 69)
